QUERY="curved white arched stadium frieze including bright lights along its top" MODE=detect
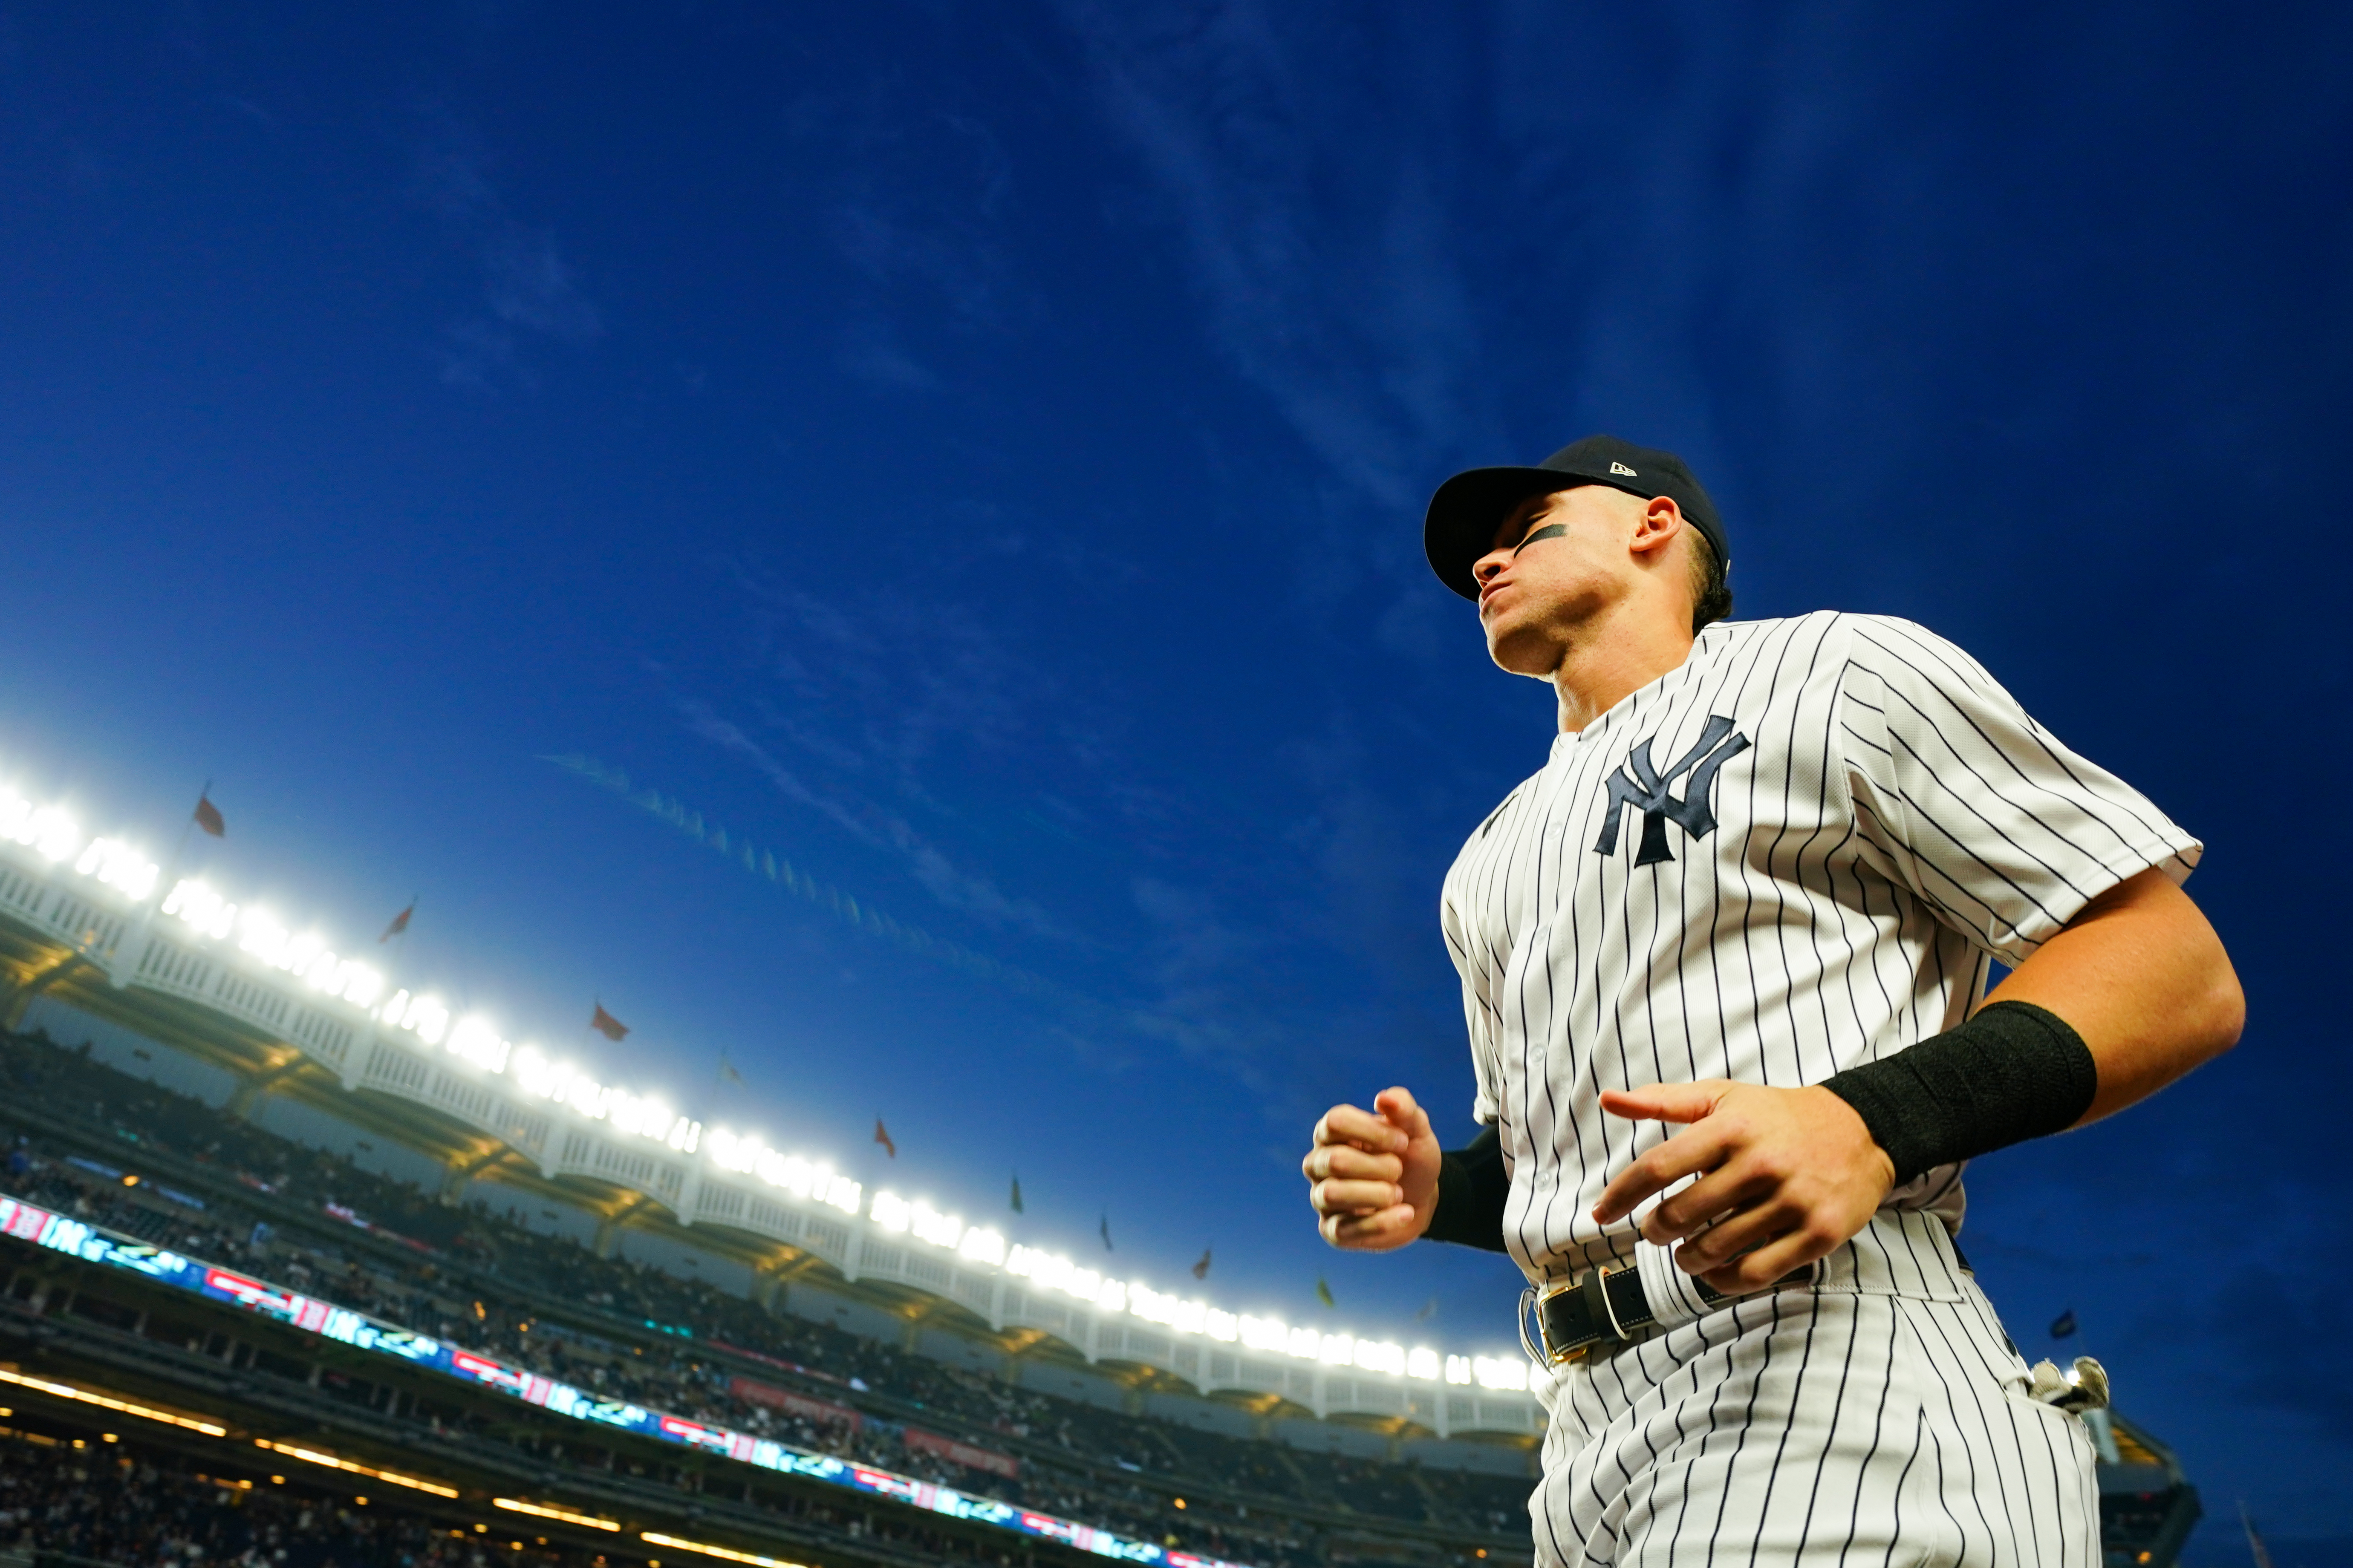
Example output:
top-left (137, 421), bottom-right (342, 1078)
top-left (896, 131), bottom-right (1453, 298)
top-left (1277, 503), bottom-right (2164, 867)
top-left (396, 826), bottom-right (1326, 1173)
top-left (0, 766), bottom-right (1541, 1439)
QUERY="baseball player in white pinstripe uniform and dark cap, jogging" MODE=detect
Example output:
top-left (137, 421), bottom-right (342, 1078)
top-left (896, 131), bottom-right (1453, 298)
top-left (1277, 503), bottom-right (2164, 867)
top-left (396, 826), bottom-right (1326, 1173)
top-left (1304, 435), bottom-right (2245, 1568)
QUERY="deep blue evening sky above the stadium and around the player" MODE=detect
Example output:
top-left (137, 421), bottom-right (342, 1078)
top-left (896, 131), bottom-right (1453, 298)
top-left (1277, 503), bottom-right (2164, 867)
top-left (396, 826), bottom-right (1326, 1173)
top-left (0, 0), bottom-right (2353, 1561)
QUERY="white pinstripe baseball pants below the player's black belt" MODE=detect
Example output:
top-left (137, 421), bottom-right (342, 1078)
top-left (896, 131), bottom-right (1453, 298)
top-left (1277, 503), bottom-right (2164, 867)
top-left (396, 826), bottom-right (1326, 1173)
top-left (1530, 1211), bottom-right (2101, 1568)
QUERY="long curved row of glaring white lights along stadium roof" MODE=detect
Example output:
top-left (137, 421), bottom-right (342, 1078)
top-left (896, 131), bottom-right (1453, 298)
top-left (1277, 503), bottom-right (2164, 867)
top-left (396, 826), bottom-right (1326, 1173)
top-left (0, 785), bottom-right (1527, 1392)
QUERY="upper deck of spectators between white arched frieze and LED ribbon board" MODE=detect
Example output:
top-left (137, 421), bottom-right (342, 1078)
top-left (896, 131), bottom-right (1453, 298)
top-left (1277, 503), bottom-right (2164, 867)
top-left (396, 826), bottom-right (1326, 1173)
top-left (0, 1037), bottom-right (1527, 1565)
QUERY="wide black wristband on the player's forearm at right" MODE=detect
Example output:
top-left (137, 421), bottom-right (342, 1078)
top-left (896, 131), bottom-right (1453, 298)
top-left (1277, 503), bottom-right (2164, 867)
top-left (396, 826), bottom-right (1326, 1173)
top-left (1821, 1001), bottom-right (2099, 1187)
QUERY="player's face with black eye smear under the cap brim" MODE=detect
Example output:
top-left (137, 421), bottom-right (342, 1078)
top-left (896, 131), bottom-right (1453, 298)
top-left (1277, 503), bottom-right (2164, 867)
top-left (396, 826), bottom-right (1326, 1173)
top-left (1471, 484), bottom-right (1643, 679)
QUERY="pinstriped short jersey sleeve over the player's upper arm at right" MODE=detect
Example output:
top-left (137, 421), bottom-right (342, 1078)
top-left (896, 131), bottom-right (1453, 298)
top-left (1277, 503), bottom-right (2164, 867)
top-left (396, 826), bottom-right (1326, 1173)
top-left (1833, 616), bottom-right (2203, 964)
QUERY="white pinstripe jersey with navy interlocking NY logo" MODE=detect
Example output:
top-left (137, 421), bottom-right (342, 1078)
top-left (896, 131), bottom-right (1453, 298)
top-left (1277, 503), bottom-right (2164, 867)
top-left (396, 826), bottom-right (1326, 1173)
top-left (1440, 614), bottom-right (2200, 1279)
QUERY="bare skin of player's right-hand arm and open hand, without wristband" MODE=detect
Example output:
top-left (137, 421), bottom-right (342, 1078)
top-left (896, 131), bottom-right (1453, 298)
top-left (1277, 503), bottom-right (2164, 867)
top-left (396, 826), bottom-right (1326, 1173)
top-left (1593, 870), bottom-right (2247, 1293)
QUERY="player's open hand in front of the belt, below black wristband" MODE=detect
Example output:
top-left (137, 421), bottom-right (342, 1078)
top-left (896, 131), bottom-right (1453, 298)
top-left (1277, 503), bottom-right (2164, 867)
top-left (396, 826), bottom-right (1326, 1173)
top-left (1593, 1079), bottom-right (1897, 1295)
